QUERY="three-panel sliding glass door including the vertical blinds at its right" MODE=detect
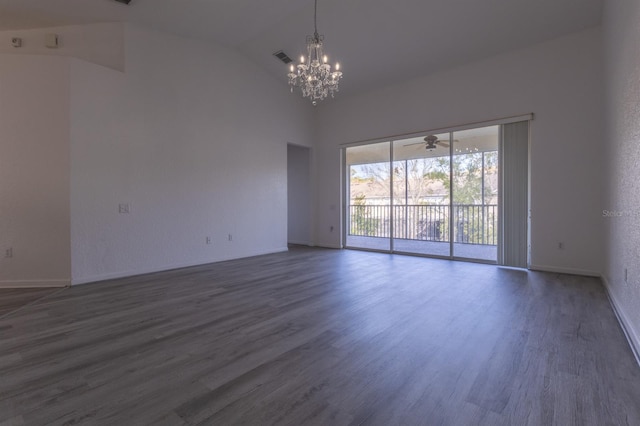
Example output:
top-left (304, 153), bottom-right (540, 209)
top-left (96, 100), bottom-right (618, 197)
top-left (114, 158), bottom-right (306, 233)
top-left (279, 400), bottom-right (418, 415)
top-left (345, 117), bottom-right (528, 267)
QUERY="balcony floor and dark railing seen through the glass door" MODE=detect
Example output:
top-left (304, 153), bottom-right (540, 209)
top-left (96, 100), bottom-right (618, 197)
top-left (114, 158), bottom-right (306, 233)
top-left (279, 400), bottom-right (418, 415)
top-left (347, 204), bottom-right (498, 261)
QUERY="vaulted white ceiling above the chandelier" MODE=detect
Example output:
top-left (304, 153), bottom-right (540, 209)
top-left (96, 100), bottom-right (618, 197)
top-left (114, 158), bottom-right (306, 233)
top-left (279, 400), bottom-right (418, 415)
top-left (0, 0), bottom-right (603, 93)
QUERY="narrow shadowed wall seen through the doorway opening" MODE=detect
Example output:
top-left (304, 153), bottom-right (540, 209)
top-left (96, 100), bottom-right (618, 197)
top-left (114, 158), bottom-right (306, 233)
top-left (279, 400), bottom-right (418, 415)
top-left (287, 145), bottom-right (312, 245)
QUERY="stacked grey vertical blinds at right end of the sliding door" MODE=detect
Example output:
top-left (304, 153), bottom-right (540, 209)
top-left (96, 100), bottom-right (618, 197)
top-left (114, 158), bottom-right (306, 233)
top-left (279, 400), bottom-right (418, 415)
top-left (502, 121), bottom-right (529, 268)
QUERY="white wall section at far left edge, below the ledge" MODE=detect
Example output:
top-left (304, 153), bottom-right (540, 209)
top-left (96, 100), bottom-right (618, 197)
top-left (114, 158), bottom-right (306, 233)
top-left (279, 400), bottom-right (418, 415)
top-left (0, 55), bottom-right (71, 287)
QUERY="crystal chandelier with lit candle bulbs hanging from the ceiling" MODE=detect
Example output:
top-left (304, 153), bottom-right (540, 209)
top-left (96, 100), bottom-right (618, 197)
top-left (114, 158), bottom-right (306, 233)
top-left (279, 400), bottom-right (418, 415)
top-left (288, 0), bottom-right (342, 106)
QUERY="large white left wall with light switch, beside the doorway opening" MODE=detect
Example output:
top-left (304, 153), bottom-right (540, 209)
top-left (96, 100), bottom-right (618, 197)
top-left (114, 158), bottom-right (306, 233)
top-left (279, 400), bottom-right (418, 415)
top-left (71, 26), bottom-right (312, 283)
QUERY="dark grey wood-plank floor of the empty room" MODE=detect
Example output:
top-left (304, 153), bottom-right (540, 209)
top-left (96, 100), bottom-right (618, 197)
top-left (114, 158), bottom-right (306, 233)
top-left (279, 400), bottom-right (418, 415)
top-left (0, 248), bottom-right (640, 426)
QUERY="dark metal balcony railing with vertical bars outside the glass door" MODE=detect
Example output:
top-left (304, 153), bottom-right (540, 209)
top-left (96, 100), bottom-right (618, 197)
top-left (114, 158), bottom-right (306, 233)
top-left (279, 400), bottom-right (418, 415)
top-left (349, 204), bottom-right (498, 245)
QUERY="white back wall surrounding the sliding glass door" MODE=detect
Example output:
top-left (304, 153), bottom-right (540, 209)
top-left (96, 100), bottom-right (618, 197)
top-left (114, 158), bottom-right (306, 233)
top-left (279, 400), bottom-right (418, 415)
top-left (316, 28), bottom-right (603, 275)
